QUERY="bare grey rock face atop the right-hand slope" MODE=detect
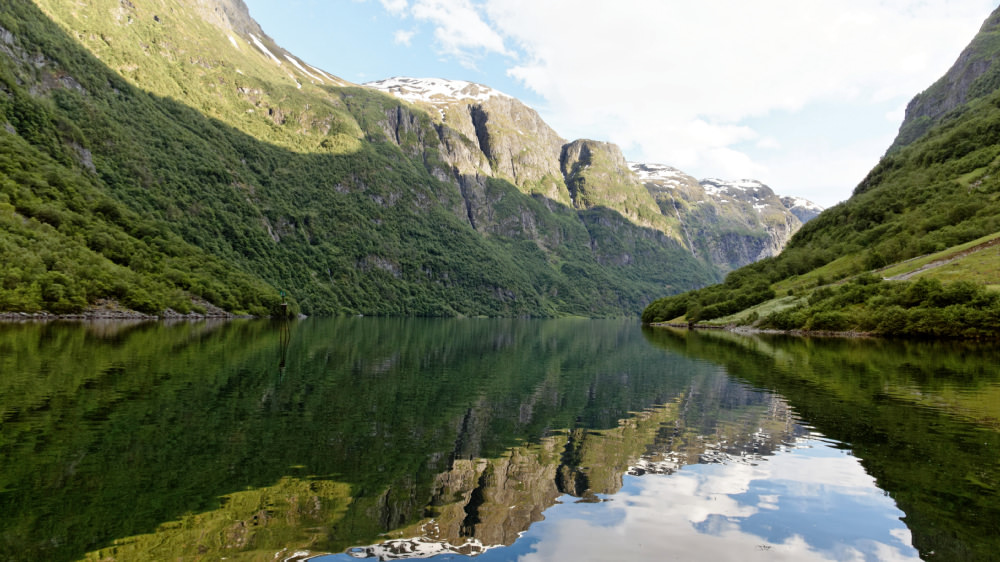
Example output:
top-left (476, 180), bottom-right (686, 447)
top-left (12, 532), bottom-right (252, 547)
top-left (887, 8), bottom-right (1000, 153)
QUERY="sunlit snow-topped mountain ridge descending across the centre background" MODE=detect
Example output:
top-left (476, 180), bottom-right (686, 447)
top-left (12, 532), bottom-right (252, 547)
top-left (363, 77), bottom-right (819, 272)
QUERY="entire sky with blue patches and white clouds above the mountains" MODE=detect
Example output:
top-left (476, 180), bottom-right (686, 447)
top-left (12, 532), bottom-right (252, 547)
top-left (245, 0), bottom-right (998, 206)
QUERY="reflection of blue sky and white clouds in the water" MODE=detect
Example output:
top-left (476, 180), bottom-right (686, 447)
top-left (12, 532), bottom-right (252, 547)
top-left (512, 437), bottom-right (919, 562)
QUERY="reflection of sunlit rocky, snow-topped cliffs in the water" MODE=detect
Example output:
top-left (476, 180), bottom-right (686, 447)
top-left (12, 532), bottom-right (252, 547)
top-left (338, 371), bottom-right (809, 560)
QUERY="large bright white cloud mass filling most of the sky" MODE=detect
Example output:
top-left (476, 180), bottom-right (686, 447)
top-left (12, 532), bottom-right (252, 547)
top-left (372, 0), bottom-right (996, 200)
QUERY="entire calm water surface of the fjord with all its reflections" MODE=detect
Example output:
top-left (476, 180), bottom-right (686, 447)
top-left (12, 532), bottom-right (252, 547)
top-left (0, 318), bottom-right (1000, 562)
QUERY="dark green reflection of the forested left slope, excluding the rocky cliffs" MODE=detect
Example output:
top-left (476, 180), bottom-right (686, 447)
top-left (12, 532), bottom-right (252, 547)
top-left (0, 318), bottom-right (711, 560)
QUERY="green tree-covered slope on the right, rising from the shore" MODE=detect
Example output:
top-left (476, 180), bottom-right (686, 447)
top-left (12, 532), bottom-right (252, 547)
top-left (643, 5), bottom-right (1000, 336)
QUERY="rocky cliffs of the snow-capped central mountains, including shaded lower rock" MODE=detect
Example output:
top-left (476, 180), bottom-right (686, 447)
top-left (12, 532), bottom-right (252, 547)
top-left (365, 78), bottom-right (821, 272)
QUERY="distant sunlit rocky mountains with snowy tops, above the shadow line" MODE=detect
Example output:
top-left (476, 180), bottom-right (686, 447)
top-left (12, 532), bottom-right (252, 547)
top-left (364, 77), bottom-right (819, 273)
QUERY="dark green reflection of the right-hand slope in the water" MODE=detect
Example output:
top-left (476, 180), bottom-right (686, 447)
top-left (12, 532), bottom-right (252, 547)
top-left (644, 329), bottom-right (1000, 560)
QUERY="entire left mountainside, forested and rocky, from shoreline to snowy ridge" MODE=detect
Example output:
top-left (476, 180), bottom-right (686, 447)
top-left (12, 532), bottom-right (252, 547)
top-left (0, 0), bottom-right (812, 316)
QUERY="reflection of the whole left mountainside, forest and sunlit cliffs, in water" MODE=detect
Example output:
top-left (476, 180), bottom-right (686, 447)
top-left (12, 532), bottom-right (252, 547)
top-left (0, 319), bottom-right (900, 560)
